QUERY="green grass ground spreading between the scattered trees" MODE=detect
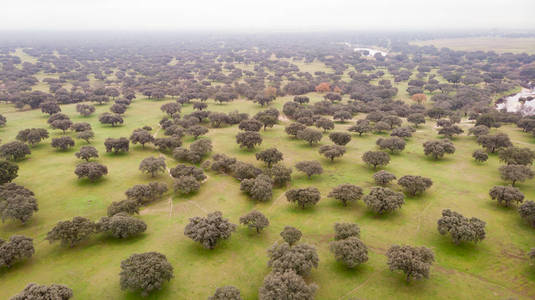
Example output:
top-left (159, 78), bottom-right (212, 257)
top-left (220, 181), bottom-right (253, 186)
top-left (0, 94), bottom-right (535, 299)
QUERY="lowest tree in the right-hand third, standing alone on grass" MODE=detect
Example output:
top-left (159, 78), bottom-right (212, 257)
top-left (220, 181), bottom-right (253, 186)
top-left (386, 245), bottom-right (435, 282)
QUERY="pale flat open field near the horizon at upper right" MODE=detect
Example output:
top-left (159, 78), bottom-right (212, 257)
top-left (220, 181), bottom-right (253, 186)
top-left (411, 37), bottom-right (535, 54)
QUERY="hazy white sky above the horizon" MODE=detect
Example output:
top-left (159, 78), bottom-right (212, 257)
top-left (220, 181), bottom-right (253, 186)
top-left (0, 0), bottom-right (535, 31)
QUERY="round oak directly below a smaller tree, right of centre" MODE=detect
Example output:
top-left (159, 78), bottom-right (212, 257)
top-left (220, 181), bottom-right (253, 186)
top-left (363, 187), bottom-right (405, 214)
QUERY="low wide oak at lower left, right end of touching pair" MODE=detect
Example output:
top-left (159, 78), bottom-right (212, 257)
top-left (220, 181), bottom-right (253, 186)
top-left (96, 213), bottom-right (147, 239)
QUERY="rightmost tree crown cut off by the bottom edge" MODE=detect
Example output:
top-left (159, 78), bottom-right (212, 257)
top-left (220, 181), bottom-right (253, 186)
top-left (258, 270), bottom-right (318, 300)
